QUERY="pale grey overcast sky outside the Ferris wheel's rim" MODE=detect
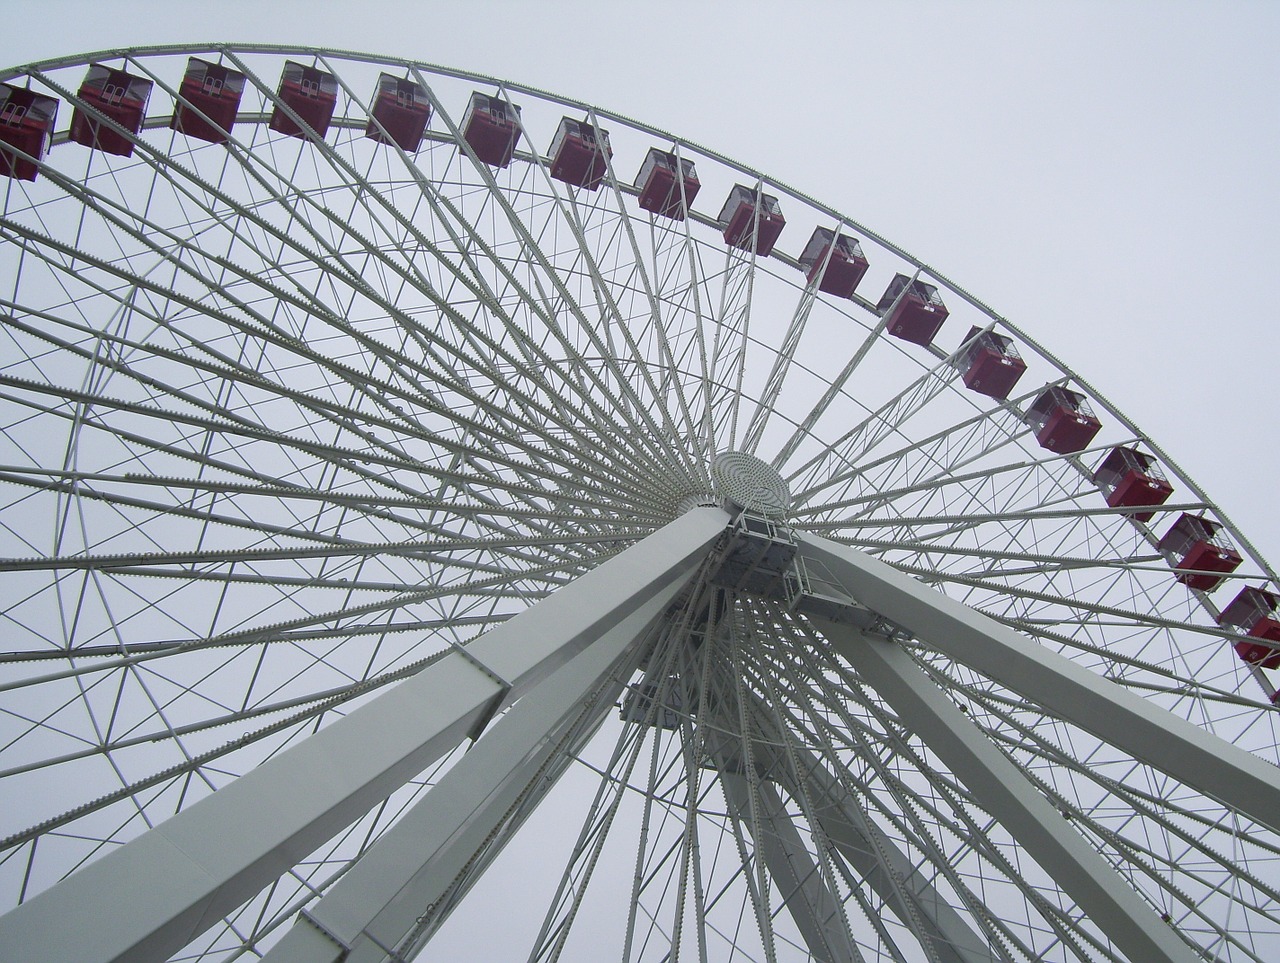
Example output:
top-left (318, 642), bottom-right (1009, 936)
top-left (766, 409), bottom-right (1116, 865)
top-left (0, 0), bottom-right (1280, 957)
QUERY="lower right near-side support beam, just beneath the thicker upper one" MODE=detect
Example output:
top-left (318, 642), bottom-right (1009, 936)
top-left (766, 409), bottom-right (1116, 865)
top-left (814, 619), bottom-right (1198, 963)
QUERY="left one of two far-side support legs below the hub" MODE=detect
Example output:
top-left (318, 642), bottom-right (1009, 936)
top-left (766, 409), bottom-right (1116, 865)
top-left (719, 768), bottom-right (859, 963)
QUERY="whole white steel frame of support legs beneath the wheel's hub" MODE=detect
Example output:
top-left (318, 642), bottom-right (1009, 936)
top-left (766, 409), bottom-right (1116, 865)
top-left (0, 508), bottom-right (1280, 963)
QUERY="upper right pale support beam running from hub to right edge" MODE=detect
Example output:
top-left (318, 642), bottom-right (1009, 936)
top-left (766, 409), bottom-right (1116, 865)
top-left (800, 534), bottom-right (1280, 832)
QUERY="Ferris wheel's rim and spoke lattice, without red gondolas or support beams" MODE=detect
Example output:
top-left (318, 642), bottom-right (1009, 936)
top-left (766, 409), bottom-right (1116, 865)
top-left (0, 47), bottom-right (1280, 959)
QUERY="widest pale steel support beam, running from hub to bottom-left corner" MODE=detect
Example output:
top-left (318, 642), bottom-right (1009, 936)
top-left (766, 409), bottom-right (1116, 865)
top-left (0, 508), bottom-right (727, 963)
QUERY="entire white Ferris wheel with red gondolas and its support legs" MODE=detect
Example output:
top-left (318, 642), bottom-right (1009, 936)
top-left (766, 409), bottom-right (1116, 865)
top-left (0, 45), bottom-right (1280, 963)
